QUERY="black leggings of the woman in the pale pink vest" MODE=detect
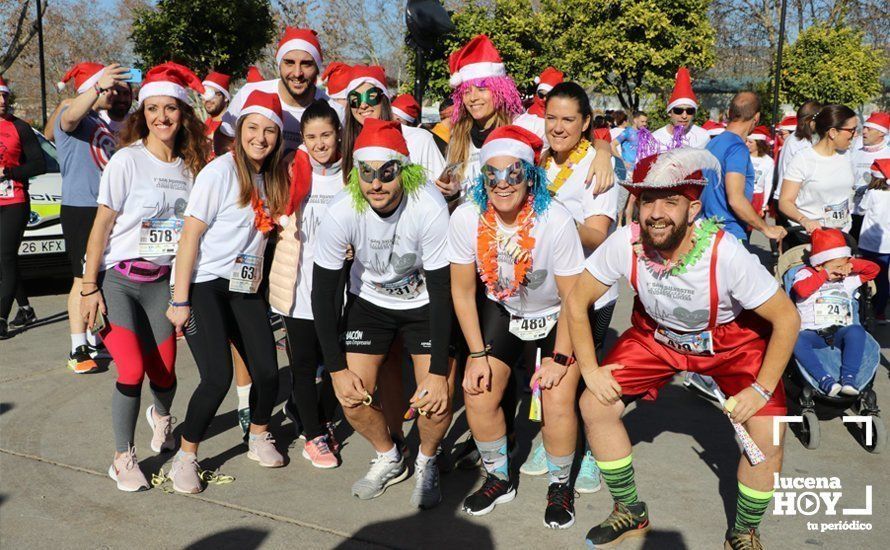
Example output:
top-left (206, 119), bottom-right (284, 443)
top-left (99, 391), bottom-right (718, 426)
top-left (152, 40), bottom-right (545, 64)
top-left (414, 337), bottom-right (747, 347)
top-left (281, 315), bottom-right (337, 440)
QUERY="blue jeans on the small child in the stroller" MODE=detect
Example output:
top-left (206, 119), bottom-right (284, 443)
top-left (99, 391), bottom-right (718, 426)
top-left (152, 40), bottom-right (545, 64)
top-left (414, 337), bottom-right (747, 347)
top-left (794, 325), bottom-right (868, 393)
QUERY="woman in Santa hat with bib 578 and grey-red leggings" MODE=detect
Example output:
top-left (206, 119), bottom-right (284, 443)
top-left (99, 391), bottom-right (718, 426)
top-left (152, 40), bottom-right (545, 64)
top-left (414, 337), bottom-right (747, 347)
top-left (80, 63), bottom-right (207, 492)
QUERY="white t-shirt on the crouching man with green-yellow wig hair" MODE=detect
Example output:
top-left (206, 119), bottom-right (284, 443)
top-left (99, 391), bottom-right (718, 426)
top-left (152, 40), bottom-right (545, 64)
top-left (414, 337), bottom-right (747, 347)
top-left (315, 184), bottom-right (448, 310)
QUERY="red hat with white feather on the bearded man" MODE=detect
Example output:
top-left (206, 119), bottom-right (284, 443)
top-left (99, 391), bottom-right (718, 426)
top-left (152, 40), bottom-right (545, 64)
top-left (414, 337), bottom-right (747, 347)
top-left (622, 147), bottom-right (720, 201)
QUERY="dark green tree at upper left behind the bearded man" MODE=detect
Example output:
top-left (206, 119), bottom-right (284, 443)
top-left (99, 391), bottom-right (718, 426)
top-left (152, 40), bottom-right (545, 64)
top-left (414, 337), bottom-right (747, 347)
top-left (131, 0), bottom-right (275, 76)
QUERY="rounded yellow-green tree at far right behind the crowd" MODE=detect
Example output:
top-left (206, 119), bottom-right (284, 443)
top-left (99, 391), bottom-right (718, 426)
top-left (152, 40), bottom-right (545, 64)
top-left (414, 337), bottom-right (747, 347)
top-left (780, 24), bottom-right (887, 107)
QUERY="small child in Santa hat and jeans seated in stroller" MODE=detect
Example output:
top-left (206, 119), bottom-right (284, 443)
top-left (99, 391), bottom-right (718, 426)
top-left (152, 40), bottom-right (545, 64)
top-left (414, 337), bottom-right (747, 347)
top-left (791, 229), bottom-right (880, 397)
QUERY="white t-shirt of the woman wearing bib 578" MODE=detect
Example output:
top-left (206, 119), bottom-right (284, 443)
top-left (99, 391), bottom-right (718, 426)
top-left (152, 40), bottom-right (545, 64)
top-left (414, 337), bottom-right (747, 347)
top-left (97, 141), bottom-right (192, 269)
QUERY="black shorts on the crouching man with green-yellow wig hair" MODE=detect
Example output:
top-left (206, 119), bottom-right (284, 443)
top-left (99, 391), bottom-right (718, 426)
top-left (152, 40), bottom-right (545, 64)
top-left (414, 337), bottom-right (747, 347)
top-left (343, 295), bottom-right (432, 355)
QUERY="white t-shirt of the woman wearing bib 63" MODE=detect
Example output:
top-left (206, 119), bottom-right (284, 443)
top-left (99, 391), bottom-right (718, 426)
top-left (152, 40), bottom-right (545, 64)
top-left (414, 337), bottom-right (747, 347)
top-left (185, 153), bottom-right (266, 283)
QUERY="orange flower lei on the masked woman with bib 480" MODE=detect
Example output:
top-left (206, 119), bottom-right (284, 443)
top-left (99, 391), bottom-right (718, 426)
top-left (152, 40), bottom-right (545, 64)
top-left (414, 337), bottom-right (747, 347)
top-left (476, 195), bottom-right (535, 302)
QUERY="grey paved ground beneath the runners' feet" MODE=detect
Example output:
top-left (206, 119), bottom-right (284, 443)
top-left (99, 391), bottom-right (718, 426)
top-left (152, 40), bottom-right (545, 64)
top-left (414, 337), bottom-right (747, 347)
top-left (0, 245), bottom-right (890, 550)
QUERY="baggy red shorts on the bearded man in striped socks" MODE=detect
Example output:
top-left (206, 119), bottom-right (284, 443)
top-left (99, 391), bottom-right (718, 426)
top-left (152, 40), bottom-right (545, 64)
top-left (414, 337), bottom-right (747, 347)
top-left (603, 304), bottom-right (787, 416)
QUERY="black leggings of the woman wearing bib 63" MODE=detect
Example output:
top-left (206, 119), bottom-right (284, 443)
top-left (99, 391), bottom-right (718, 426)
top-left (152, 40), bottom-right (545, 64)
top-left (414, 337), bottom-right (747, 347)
top-left (182, 279), bottom-right (278, 443)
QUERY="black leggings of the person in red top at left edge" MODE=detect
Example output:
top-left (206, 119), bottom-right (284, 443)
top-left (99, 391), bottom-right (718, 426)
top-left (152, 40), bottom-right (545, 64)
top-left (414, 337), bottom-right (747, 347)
top-left (0, 202), bottom-right (31, 320)
